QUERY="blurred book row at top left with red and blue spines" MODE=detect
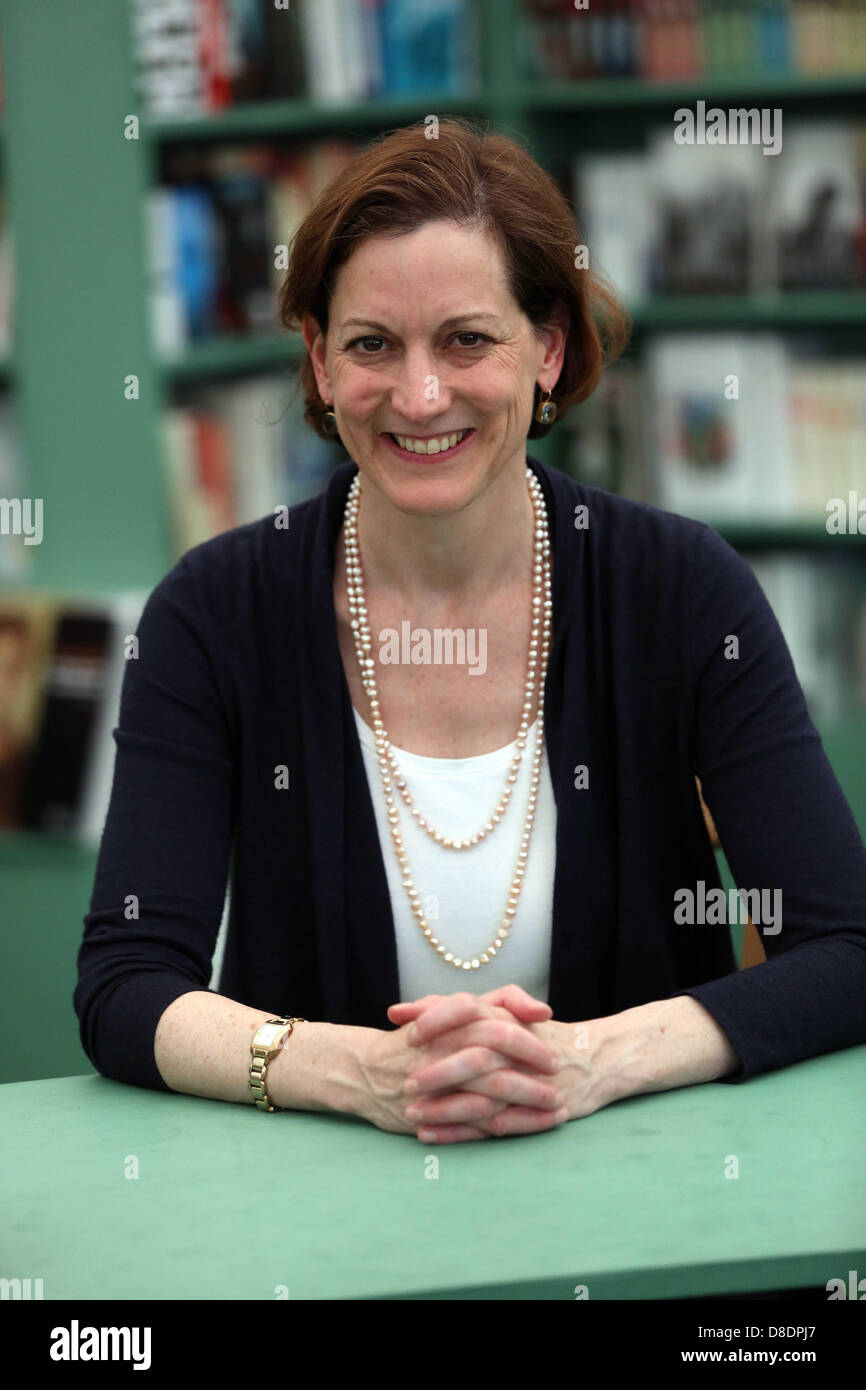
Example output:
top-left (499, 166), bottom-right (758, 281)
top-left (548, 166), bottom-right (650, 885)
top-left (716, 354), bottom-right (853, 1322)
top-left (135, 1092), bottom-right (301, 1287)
top-left (131, 0), bottom-right (480, 118)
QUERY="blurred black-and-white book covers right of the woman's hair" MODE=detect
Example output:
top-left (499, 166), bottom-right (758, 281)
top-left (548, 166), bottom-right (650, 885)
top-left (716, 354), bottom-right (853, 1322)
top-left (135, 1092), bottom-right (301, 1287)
top-left (574, 120), bottom-right (866, 306)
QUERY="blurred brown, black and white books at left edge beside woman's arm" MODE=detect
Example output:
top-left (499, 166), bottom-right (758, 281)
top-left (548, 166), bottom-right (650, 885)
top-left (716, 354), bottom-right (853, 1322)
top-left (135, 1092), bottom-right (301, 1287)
top-left (0, 592), bottom-right (146, 845)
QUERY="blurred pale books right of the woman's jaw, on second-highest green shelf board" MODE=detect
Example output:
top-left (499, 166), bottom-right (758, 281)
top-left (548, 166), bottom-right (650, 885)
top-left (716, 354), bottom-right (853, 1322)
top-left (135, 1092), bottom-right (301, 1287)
top-left (563, 332), bottom-right (866, 535)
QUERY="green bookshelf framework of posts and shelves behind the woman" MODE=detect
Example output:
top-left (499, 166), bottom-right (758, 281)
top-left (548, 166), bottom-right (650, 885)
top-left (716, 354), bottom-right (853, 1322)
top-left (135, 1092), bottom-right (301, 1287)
top-left (0, 0), bottom-right (866, 1081)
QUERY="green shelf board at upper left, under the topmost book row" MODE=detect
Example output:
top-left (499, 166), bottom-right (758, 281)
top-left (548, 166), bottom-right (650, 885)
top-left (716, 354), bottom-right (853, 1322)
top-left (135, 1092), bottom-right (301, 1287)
top-left (142, 92), bottom-right (487, 145)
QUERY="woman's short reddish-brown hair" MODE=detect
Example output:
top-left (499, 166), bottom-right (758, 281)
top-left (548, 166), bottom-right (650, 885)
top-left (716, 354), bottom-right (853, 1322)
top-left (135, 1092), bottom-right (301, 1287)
top-left (279, 118), bottom-right (631, 439)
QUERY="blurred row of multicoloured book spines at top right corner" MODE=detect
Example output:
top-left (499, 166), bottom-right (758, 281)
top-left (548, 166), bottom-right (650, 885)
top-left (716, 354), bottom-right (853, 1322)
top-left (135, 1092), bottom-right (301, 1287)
top-left (520, 0), bottom-right (866, 82)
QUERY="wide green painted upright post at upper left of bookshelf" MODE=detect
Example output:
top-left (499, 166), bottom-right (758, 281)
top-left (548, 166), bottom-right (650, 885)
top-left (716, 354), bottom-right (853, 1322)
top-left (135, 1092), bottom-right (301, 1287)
top-left (0, 0), bottom-right (170, 592)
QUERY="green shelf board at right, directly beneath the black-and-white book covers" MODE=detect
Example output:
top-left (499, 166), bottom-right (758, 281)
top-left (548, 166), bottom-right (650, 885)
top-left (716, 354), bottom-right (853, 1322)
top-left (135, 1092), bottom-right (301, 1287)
top-left (631, 288), bottom-right (866, 331)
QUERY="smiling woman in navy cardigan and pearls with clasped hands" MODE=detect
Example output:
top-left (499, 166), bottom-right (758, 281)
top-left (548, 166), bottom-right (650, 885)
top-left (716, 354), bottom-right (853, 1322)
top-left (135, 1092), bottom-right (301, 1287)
top-left (75, 121), bottom-right (866, 1143)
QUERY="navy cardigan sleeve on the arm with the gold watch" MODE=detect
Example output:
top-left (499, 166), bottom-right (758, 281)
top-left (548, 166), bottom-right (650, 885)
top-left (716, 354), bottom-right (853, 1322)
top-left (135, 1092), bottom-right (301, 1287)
top-left (74, 557), bottom-right (235, 1091)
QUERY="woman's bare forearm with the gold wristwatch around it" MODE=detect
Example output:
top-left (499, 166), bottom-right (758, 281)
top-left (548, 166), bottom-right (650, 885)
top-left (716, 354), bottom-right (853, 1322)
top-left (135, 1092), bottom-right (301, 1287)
top-left (153, 990), bottom-right (377, 1115)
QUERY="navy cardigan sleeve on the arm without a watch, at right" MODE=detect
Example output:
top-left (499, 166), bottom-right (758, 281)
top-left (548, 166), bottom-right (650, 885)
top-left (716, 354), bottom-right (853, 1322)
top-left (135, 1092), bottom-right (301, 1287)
top-left (677, 525), bottom-right (866, 1081)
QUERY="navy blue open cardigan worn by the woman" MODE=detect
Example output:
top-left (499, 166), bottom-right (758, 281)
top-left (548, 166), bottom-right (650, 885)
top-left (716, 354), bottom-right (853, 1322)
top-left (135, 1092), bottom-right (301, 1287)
top-left (74, 459), bottom-right (866, 1090)
